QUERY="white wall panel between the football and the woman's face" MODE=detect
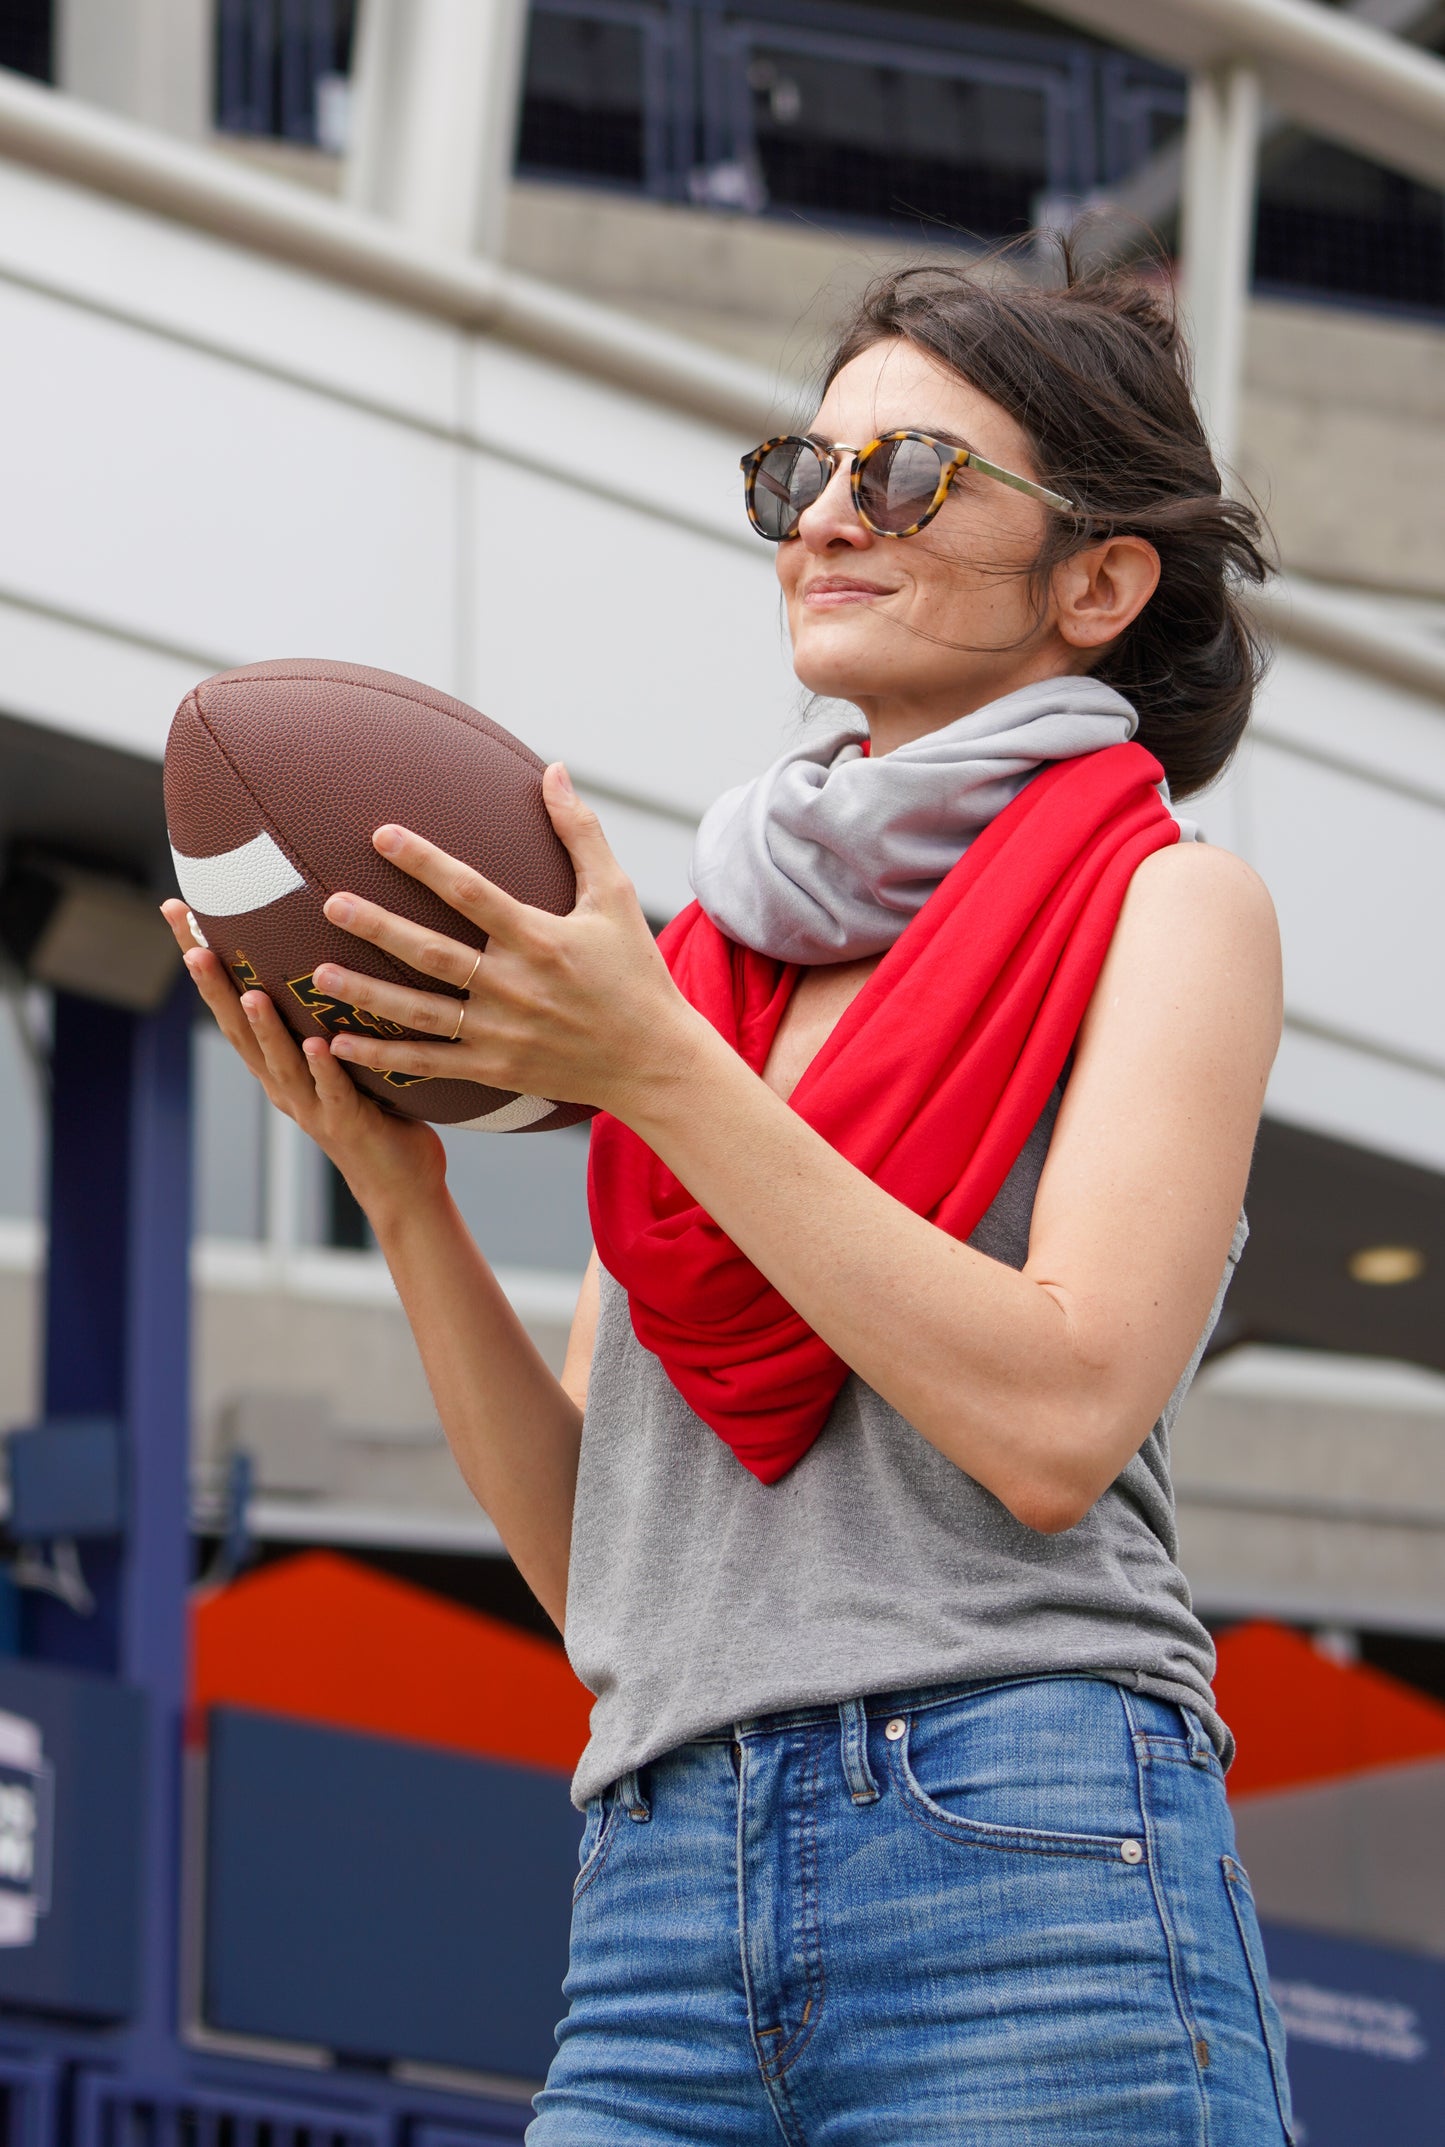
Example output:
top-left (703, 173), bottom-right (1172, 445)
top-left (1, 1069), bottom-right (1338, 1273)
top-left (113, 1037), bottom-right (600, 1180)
top-left (468, 457), bottom-right (799, 812)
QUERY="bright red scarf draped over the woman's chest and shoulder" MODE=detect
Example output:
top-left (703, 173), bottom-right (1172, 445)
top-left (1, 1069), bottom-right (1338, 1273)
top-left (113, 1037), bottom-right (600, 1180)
top-left (588, 745), bottom-right (1179, 1484)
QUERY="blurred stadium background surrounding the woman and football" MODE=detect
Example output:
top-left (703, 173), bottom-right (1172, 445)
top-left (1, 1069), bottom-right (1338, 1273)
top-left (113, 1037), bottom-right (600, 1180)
top-left (0, 0), bottom-right (1445, 2147)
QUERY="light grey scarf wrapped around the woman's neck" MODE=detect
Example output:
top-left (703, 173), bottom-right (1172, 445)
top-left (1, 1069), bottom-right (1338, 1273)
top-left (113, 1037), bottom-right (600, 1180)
top-left (691, 678), bottom-right (1194, 962)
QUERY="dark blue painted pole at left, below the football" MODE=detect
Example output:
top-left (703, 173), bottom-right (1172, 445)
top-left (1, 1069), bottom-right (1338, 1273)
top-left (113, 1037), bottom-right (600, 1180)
top-left (26, 977), bottom-right (193, 2072)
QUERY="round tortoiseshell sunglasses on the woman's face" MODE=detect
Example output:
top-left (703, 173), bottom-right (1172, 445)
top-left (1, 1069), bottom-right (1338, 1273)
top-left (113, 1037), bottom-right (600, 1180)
top-left (743, 432), bottom-right (1076, 543)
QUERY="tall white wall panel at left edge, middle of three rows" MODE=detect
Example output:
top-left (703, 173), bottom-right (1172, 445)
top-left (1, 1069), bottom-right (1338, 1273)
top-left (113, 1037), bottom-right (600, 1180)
top-left (0, 272), bottom-right (457, 685)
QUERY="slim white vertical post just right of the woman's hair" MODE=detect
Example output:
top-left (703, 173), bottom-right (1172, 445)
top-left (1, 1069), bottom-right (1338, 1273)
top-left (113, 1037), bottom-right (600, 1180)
top-left (1181, 62), bottom-right (1260, 462)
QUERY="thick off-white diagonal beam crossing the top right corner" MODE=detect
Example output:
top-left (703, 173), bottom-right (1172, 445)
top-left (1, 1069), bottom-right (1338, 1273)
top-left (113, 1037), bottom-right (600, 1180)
top-left (1048, 0), bottom-right (1445, 187)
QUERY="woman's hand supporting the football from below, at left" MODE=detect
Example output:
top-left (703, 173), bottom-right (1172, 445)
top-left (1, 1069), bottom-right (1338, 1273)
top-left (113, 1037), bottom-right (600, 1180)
top-left (161, 900), bottom-right (447, 1232)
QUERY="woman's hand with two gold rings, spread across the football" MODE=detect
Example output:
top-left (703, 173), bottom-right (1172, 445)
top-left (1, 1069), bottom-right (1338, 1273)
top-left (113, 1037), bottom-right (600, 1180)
top-left (316, 762), bottom-right (706, 1119)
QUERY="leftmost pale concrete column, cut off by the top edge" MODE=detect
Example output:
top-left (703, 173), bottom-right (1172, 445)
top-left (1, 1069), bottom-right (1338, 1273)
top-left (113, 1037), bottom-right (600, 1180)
top-left (56, 0), bottom-right (215, 142)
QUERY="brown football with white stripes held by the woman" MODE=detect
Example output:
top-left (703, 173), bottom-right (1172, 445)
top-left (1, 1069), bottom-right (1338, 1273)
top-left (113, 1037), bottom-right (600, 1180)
top-left (165, 659), bottom-right (590, 1134)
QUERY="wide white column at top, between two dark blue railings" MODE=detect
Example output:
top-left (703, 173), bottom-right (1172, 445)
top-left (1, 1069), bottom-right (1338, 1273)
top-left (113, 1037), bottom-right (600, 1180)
top-left (344, 0), bottom-right (526, 258)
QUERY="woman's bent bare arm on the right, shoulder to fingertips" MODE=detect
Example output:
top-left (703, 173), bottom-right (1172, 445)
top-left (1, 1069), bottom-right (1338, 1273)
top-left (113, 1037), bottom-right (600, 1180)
top-left (318, 775), bottom-right (1280, 1531)
